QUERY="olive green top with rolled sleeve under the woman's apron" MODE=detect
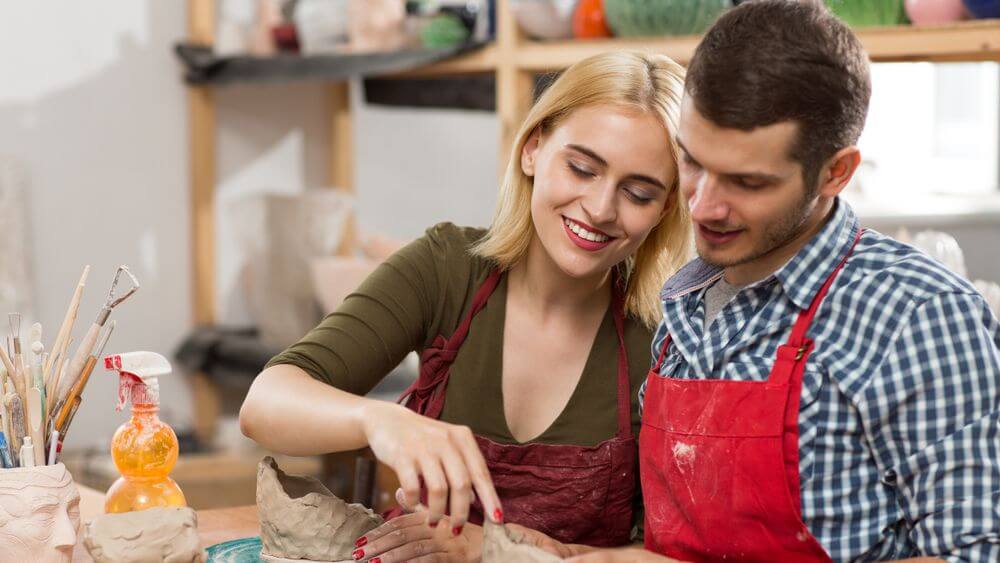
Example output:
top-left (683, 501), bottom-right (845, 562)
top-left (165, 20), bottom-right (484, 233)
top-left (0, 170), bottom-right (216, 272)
top-left (268, 223), bottom-right (652, 446)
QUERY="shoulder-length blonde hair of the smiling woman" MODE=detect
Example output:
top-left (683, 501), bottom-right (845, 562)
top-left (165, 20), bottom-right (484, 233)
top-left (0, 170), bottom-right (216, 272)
top-left (472, 51), bottom-right (691, 328)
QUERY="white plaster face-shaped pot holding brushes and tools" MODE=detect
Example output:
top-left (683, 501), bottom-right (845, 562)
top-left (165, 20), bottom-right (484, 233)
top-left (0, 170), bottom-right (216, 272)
top-left (0, 463), bottom-right (80, 563)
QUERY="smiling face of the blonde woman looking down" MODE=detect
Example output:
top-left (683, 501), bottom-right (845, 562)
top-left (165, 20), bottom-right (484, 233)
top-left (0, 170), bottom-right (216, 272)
top-left (521, 105), bottom-right (677, 278)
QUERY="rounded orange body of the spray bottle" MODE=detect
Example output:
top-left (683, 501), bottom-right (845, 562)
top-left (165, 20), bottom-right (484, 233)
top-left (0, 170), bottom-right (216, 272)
top-left (104, 403), bottom-right (187, 513)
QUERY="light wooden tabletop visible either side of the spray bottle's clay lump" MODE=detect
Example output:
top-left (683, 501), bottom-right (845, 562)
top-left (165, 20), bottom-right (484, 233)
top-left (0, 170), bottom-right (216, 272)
top-left (73, 486), bottom-right (260, 563)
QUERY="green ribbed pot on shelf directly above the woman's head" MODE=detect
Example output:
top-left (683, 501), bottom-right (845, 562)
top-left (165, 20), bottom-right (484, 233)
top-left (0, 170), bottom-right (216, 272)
top-left (604, 0), bottom-right (732, 37)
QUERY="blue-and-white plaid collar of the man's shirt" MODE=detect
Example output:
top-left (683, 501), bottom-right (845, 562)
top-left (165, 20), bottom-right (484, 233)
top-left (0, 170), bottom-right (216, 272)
top-left (660, 197), bottom-right (861, 309)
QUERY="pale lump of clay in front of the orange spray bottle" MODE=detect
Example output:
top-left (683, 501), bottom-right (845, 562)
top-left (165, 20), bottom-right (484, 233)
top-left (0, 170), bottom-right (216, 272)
top-left (83, 507), bottom-right (205, 563)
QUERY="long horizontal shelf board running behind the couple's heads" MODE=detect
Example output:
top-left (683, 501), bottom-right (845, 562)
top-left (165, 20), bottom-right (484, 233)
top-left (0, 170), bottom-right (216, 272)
top-left (178, 20), bottom-right (1000, 84)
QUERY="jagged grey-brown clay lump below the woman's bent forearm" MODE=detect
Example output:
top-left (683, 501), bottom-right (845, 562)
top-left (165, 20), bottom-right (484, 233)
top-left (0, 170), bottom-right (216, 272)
top-left (257, 456), bottom-right (383, 561)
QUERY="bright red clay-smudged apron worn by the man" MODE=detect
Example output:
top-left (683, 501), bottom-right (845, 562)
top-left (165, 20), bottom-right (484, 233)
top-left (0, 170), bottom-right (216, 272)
top-left (639, 233), bottom-right (861, 561)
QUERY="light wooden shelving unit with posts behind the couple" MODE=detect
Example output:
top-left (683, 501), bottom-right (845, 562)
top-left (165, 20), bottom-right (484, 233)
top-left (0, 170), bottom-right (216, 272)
top-left (188, 0), bottom-right (1000, 410)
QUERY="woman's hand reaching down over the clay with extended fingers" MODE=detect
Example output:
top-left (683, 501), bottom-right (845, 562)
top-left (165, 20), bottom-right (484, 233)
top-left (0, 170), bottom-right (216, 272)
top-left (362, 402), bottom-right (503, 529)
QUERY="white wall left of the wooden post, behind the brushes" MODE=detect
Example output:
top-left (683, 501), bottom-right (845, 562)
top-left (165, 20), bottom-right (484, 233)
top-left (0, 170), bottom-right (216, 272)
top-left (0, 0), bottom-right (190, 447)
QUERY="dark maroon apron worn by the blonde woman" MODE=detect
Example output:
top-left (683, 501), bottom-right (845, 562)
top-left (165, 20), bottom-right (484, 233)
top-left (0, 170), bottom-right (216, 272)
top-left (390, 271), bottom-right (636, 547)
